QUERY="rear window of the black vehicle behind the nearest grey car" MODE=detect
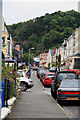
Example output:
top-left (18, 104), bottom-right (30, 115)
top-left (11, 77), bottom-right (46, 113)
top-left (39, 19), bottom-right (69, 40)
top-left (57, 73), bottom-right (77, 80)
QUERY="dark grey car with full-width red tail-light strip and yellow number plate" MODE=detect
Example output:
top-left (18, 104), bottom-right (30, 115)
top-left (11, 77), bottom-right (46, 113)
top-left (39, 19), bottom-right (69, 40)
top-left (57, 80), bottom-right (80, 103)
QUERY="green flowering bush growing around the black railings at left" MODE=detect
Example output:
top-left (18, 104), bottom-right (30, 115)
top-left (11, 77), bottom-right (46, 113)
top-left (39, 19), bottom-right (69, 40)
top-left (1, 60), bottom-right (19, 98)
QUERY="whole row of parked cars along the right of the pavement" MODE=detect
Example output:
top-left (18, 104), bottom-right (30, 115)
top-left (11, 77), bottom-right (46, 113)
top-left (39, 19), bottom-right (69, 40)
top-left (37, 69), bottom-right (80, 103)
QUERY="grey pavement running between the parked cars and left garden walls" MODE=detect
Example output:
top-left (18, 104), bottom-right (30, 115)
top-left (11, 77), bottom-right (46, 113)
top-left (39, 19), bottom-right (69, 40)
top-left (10, 72), bottom-right (68, 120)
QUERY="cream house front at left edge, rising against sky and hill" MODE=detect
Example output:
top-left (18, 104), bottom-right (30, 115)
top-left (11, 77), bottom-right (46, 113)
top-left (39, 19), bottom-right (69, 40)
top-left (2, 18), bottom-right (12, 66)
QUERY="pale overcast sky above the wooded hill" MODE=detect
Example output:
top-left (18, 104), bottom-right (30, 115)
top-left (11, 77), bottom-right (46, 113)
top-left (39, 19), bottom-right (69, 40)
top-left (2, 0), bottom-right (79, 25)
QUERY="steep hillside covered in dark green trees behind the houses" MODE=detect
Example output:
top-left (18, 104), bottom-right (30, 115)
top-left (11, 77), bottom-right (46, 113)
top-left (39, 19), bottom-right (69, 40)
top-left (7, 10), bottom-right (80, 54)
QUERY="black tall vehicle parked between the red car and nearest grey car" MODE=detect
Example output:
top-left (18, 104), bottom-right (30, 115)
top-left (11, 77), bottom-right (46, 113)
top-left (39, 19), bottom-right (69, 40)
top-left (51, 71), bottom-right (78, 98)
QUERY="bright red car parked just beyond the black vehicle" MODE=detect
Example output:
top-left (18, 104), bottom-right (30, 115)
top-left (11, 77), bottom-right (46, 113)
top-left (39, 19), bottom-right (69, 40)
top-left (42, 72), bottom-right (55, 86)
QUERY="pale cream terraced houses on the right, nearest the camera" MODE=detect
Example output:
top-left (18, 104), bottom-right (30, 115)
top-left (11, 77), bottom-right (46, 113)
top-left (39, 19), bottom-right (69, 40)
top-left (60, 27), bottom-right (80, 70)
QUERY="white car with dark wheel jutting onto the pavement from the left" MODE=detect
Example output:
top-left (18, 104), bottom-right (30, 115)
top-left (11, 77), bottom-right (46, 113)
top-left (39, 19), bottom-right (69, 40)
top-left (19, 77), bottom-right (34, 91)
